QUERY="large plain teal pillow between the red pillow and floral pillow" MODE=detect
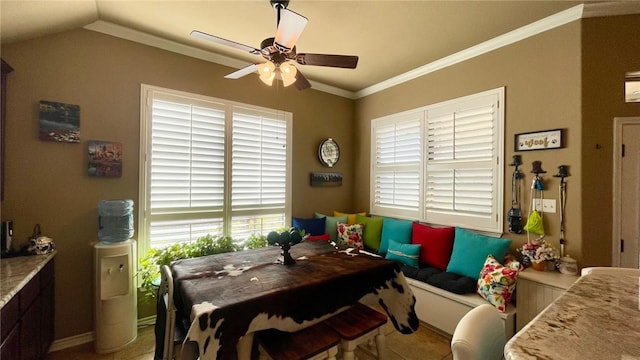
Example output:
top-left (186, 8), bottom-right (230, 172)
top-left (447, 227), bottom-right (511, 279)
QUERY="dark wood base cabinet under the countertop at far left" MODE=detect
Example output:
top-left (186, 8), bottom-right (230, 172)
top-left (0, 255), bottom-right (55, 360)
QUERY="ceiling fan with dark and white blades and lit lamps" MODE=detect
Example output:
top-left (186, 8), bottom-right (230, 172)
top-left (191, 0), bottom-right (358, 90)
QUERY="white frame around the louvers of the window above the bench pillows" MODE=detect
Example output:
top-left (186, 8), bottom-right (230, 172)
top-left (369, 87), bottom-right (505, 235)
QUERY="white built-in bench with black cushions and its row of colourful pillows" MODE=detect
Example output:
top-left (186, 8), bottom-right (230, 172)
top-left (302, 211), bottom-right (519, 338)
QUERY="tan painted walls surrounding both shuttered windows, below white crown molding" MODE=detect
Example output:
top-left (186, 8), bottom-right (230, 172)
top-left (2, 11), bottom-right (640, 339)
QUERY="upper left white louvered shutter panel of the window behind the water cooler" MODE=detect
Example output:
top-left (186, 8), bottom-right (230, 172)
top-left (151, 98), bottom-right (225, 215)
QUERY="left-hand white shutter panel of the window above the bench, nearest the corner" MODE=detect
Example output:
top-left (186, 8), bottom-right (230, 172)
top-left (371, 114), bottom-right (422, 218)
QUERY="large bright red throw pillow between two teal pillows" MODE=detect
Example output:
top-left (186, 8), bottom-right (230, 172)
top-left (411, 222), bottom-right (455, 271)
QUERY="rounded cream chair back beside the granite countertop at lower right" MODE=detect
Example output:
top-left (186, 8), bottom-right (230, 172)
top-left (451, 304), bottom-right (507, 360)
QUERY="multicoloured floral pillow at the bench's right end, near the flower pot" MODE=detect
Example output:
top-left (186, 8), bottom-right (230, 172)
top-left (477, 255), bottom-right (520, 312)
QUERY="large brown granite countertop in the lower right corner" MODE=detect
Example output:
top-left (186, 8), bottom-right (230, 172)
top-left (504, 274), bottom-right (640, 360)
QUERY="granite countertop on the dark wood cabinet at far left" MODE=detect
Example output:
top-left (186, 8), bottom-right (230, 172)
top-left (0, 251), bottom-right (56, 309)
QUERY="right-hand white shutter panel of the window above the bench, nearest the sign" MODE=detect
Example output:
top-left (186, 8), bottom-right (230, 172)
top-left (424, 90), bottom-right (502, 230)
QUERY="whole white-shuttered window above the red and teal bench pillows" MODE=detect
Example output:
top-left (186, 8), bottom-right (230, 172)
top-left (370, 88), bottom-right (504, 233)
